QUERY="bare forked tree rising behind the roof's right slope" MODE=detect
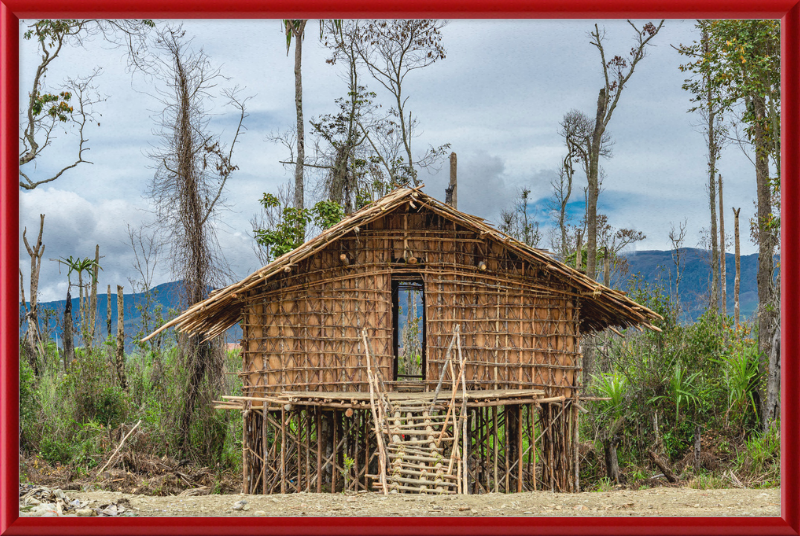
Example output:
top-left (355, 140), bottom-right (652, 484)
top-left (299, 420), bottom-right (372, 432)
top-left (586, 20), bottom-right (664, 279)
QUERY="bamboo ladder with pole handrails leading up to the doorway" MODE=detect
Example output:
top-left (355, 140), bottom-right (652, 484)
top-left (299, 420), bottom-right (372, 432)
top-left (361, 326), bottom-right (467, 494)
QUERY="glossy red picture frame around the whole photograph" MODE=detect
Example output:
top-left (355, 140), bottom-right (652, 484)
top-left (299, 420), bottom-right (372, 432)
top-left (0, 0), bottom-right (800, 536)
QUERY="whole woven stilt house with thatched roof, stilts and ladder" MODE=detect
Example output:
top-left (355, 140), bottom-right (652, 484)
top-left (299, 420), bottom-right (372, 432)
top-left (147, 189), bottom-right (659, 493)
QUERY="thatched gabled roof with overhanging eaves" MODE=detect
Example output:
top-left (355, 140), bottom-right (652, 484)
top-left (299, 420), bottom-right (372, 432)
top-left (145, 188), bottom-right (661, 340)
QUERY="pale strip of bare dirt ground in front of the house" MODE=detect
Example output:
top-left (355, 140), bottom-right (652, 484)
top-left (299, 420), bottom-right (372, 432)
top-left (34, 487), bottom-right (780, 517)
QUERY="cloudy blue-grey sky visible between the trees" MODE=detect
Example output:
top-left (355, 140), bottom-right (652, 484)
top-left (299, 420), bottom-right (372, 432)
top-left (19, 20), bottom-right (756, 301)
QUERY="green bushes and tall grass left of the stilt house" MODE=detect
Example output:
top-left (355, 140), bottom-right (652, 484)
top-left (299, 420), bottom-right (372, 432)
top-left (20, 340), bottom-right (242, 486)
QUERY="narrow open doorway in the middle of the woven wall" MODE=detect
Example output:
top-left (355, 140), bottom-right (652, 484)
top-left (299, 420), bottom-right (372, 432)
top-left (392, 276), bottom-right (426, 381)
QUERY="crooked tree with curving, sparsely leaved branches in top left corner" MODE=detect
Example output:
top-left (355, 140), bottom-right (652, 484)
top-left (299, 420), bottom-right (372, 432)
top-left (19, 19), bottom-right (154, 190)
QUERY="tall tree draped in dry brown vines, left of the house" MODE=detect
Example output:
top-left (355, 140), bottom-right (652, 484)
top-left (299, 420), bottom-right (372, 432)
top-left (149, 27), bottom-right (247, 450)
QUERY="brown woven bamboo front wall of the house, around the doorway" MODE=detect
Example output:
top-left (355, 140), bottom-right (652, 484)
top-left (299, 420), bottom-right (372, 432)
top-left (242, 205), bottom-right (580, 396)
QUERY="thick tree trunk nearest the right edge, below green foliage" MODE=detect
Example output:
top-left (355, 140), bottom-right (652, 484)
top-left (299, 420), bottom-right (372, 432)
top-left (752, 95), bottom-right (776, 428)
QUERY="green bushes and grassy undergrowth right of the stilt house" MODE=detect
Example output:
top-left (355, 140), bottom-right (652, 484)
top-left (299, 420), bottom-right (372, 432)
top-left (581, 277), bottom-right (780, 490)
